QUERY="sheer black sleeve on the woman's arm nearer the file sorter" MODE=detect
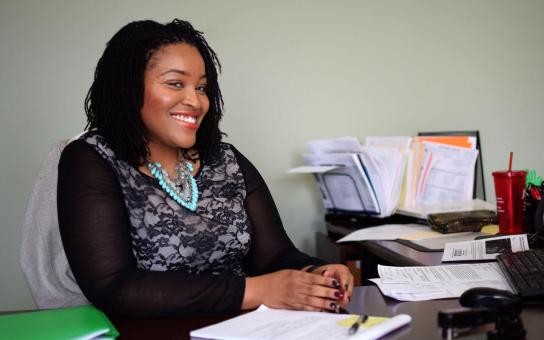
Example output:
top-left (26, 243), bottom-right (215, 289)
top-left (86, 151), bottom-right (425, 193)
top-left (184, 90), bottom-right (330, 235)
top-left (233, 147), bottom-right (326, 275)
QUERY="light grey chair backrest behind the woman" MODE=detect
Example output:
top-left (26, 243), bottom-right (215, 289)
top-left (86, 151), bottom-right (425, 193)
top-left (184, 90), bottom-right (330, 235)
top-left (20, 139), bottom-right (89, 309)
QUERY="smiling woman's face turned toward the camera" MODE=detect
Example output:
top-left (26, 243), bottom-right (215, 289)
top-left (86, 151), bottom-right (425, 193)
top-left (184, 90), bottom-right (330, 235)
top-left (141, 43), bottom-right (210, 153)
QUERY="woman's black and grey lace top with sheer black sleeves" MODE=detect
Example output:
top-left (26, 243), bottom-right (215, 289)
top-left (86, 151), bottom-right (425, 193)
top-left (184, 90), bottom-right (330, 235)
top-left (58, 133), bottom-right (323, 317)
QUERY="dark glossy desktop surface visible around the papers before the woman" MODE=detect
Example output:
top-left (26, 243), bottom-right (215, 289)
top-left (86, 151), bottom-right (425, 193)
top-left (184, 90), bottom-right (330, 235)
top-left (107, 286), bottom-right (544, 340)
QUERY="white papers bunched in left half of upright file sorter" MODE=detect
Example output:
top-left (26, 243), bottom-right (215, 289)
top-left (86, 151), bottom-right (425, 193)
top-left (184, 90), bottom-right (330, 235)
top-left (291, 137), bottom-right (409, 217)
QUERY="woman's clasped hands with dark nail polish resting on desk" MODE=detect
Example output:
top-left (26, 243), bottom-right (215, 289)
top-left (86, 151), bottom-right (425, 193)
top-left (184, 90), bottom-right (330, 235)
top-left (242, 264), bottom-right (353, 312)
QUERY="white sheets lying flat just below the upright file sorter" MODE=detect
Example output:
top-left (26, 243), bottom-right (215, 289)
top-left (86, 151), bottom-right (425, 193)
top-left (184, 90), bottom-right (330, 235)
top-left (336, 224), bottom-right (438, 242)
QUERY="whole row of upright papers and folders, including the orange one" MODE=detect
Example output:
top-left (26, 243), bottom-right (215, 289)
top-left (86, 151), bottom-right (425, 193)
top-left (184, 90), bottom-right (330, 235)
top-left (290, 136), bottom-right (478, 217)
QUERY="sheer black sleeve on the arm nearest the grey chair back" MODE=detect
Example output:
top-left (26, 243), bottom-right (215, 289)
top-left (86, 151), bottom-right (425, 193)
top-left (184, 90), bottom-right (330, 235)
top-left (57, 141), bottom-right (242, 317)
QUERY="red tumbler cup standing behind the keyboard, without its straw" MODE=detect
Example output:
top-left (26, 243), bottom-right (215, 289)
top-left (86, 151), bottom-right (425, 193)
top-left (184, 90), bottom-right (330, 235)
top-left (493, 170), bottom-right (527, 234)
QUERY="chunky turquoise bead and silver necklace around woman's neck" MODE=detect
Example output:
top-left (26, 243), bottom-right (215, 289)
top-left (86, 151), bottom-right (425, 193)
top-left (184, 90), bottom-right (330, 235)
top-left (146, 155), bottom-right (198, 211)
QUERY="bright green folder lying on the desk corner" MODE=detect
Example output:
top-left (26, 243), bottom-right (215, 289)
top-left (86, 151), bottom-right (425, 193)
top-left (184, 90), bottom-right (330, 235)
top-left (0, 305), bottom-right (119, 340)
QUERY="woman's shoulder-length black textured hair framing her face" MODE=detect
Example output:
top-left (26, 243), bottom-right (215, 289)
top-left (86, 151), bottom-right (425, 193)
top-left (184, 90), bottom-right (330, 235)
top-left (85, 19), bottom-right (223, 166)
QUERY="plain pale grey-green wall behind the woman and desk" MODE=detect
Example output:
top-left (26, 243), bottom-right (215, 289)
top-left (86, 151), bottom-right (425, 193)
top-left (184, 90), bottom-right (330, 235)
top-left (0, 0), bottom-right (544, 310)
